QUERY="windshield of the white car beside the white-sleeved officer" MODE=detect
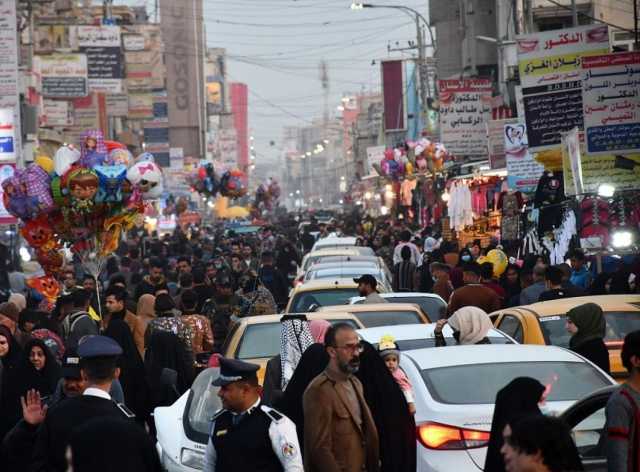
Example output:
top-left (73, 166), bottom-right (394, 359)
top-left (187, 368), bottom-right (222, 435)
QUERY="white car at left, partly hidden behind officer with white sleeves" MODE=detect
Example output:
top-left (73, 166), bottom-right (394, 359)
top-left (153, 367), bottom-right (222, 472)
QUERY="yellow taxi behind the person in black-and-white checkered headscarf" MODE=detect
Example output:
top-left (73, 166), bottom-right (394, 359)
top-left (222, 313), bottom-right (364, 384)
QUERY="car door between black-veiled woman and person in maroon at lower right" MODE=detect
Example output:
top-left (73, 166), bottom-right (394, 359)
top-left (562, 390), bottom-right (611, 472)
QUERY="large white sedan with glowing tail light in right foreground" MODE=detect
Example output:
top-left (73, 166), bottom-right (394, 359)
top-left (400, 344), bottom-right (615, 472)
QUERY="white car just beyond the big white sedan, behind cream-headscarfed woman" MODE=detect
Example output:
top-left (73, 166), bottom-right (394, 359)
top-left (357, 323), bottom-right (517, 351)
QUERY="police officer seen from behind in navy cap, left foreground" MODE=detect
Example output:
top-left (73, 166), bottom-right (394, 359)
top-left (30, 335), bottom-right (138, 472)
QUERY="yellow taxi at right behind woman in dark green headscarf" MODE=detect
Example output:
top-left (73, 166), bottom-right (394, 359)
top-left (489, 295), bottom-right (640, 378)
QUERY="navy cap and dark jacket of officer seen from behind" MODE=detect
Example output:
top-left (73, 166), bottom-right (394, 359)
top-left (30, 336), bottom-right (133, 472)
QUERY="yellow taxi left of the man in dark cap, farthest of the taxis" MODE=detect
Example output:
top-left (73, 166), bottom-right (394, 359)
top-left (285, 278), bottom-right (384, 313)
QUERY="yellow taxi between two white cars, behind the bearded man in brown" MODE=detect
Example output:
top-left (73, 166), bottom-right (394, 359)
top-left (318, 303), bottom-right (431, 328)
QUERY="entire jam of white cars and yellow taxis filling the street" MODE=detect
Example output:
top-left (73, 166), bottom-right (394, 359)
top-left (155, 237), bottom-right (640, 472)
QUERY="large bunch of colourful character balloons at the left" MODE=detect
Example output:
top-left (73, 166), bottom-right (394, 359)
top-left (2, 130), bottom-right (163, 301)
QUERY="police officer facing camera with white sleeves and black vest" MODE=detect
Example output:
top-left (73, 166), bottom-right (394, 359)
top-left (203, 358), bottom-right (304, 472)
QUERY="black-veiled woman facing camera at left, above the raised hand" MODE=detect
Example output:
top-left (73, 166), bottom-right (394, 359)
top-left (0, 339), bottom-right (61, 437)
